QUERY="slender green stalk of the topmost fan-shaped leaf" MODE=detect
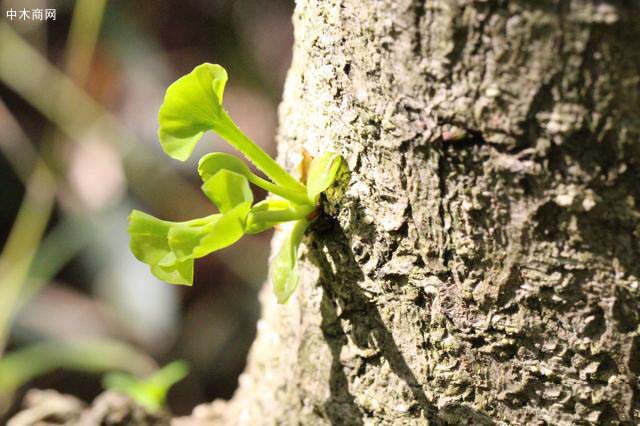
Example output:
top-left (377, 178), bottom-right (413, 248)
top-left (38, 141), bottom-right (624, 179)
top-left (214, 111), bottom-right (305, 192)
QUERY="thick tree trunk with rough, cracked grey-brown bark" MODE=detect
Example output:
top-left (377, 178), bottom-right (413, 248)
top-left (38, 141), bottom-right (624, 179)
top-left (184, 0), bottom-right (640, 425)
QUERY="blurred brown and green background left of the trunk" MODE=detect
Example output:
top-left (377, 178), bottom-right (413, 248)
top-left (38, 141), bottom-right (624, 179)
top-left (0, 0), bottom-right (293, 424)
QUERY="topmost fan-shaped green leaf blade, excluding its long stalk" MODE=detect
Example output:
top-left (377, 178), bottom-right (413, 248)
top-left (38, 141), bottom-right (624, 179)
top-left (158, 63), bottom-right (228, 161)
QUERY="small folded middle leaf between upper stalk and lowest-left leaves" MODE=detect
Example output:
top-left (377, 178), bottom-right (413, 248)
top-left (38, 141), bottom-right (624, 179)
top-left (202, 169), bottom-right (253, 213)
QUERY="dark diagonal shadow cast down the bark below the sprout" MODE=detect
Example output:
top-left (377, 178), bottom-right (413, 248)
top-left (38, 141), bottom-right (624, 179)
top-left (309, 218), bottom-right (495, 425)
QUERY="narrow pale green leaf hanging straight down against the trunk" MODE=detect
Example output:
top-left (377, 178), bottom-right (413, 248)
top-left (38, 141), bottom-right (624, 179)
top-left (270, 219), bottom-right (309, 303)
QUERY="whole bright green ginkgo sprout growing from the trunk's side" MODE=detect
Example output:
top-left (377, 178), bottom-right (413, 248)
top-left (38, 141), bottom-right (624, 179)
top-left (129, 63), bottom-right (341, 303)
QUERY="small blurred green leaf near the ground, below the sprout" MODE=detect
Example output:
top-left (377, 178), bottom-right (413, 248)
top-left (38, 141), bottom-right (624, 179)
top-left (102, 361), bottom-right (189, 412)
